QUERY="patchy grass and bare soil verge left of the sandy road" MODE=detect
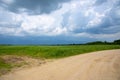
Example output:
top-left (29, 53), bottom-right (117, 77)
top-left (0, 55), bottom-right (48, 76)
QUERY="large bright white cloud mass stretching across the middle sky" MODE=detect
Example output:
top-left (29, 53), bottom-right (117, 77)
top-left (0, 0), bottom-right (120, 43)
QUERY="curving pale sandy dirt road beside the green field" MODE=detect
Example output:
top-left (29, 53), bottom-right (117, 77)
top-left (0, 50), bottom-right (120, 80)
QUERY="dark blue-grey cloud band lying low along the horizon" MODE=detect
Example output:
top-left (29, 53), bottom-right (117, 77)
top-left (0, 34), bottom-right (95, 45)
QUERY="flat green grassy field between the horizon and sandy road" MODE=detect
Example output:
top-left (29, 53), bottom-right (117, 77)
top-left (0, 45), bottom-right (120, 75)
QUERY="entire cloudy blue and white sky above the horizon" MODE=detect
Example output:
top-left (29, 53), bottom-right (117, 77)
top-left (0, 0), bottom-right (120, 44)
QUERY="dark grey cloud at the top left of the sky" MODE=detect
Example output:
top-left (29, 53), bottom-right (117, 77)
top-left (0, 0), bottom-right (70, 14)
